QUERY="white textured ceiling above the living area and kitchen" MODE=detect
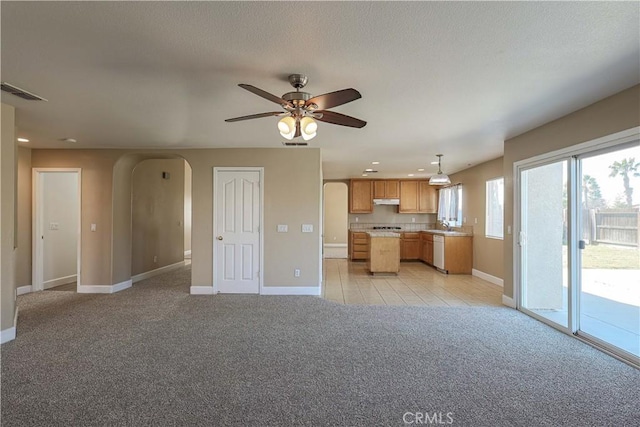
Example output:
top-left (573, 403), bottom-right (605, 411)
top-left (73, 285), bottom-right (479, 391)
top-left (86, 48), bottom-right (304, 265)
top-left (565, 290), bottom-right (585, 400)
top-left (1, 1), bottom-right (640, 179)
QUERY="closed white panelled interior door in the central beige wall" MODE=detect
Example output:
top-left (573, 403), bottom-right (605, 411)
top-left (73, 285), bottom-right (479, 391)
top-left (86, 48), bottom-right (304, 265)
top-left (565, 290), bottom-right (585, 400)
top-left (213, 168), bottom-right (261, 294)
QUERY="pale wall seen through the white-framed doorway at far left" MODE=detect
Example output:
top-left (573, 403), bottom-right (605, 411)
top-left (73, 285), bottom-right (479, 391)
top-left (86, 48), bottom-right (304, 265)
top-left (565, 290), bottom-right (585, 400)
top-left (40, 172), bottom-right (79, 289)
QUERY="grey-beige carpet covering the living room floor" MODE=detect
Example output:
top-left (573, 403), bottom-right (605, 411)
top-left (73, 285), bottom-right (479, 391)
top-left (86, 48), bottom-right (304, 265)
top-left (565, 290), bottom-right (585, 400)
top-left (1, 268), bottom-right (640, 426)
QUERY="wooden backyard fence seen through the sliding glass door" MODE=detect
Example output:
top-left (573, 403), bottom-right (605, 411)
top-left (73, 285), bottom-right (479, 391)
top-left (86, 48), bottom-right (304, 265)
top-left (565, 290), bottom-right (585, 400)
top-left (582, 208), bottom-right (640, 247)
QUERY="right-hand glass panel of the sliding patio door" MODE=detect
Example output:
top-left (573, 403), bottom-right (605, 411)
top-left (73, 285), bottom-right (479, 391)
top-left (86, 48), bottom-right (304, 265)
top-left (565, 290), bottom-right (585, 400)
top-left (577, 146), bottom-right (640, 357)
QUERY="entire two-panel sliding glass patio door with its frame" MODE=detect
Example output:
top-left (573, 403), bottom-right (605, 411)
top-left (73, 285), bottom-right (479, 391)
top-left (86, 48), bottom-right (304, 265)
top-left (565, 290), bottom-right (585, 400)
top-left (514, 130), bottom-right (640, 364)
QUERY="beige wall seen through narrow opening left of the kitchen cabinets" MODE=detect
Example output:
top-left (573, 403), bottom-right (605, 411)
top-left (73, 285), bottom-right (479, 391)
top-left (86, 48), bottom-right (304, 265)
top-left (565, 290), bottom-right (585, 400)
top-left (324, 182), bottom-right (349, 245)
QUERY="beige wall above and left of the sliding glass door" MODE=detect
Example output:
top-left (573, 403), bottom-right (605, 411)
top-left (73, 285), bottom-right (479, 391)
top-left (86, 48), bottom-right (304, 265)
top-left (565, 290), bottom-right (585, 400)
top-left (504, 85), bottom-right (640, 297)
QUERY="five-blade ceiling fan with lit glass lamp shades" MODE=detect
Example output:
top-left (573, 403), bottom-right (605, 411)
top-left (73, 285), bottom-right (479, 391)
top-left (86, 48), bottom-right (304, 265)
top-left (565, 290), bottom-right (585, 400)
top-left (225, 74), bottom-right (367, 141)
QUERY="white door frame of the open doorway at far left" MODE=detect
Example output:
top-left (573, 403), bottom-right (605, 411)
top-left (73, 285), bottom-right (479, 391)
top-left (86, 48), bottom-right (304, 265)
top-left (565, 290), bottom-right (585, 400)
top-left (31, 168), bottom-right (82, 292)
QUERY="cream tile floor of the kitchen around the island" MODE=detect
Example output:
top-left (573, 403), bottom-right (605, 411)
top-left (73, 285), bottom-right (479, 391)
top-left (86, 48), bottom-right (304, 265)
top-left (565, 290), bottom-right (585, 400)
top-left (322, 259), bottom-right (502, 307)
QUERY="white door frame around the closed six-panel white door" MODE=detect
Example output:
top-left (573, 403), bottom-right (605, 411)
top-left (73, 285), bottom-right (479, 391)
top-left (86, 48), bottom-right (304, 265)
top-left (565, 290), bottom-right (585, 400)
top-left (211, 166), bottom-right (264, 295)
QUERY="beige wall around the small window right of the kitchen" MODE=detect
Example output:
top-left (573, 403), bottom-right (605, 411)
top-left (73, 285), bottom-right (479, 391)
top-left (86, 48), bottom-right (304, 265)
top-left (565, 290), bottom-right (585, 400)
top-left (451, 157), bottom-right (506, 279)
